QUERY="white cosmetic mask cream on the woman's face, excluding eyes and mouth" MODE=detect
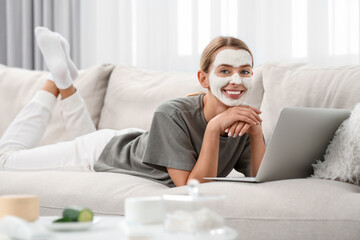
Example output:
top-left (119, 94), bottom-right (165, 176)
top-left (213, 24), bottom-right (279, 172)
top-left (209, 49), bottom-right (252, 106)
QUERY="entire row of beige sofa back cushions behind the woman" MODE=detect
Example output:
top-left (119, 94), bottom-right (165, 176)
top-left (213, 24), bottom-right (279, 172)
top-left (0, 63), bottom-right (360, 145)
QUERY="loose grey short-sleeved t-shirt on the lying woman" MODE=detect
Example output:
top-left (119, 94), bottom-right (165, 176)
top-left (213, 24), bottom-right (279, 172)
top-left (94, 95), bottom-right (251, 187)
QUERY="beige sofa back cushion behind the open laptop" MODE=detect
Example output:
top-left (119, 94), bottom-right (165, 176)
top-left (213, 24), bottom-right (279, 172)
top-left (257, 63), bottom-right (360, 142)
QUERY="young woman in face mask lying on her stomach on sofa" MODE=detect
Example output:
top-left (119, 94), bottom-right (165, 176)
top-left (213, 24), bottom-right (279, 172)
top-left (0, 27), bottom-right (265, 187)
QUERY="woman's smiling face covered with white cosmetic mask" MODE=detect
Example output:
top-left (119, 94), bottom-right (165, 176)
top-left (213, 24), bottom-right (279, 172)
top-left (209, 47), bottom-right (253, 106)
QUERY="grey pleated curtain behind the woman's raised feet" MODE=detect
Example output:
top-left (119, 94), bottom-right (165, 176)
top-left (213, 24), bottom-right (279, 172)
top-left (0, 0), bottom-right (80, 69)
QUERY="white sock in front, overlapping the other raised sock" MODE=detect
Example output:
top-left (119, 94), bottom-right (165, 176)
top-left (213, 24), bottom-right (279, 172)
top-left (35, 27), bottom-right (72, 89)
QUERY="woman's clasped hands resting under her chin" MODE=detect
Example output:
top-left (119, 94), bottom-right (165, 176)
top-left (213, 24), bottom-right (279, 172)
top-left (209, 105), bottom-right (262, 137)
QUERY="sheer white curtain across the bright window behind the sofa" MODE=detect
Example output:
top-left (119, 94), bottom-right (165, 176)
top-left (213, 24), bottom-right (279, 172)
top-left (80, 0), bottom-right (360, 72)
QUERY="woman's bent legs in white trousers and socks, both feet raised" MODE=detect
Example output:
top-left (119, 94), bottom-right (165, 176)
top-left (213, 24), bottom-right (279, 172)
top-left (0, 28), bottom-right (102, 171)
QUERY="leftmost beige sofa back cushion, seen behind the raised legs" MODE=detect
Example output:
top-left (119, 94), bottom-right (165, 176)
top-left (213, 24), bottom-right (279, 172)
top-left (0, 64), bottom-right (114, 145)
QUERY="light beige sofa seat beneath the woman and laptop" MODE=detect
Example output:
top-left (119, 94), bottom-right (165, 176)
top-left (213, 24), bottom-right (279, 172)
top-left (0, 172), bottom-right (360, 239)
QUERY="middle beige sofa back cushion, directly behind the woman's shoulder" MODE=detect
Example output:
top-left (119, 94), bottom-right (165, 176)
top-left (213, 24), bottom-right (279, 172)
top-left (99, 65), bottom-right (204, 130)
